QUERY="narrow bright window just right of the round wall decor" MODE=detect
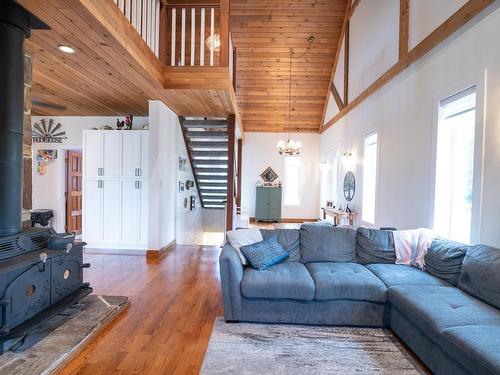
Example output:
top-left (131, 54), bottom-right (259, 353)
top-left (362, 132), bottom-right (378, 224)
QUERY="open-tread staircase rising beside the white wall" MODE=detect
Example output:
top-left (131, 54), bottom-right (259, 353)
top-left (179, 117), bottom-right (228, 210)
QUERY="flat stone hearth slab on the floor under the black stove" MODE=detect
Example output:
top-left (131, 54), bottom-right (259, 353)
top-left (0, 294), bottom-right (129, 375)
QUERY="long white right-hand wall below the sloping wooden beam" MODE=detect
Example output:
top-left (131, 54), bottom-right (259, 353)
top-left (320, 2), bottom-right (500, 250)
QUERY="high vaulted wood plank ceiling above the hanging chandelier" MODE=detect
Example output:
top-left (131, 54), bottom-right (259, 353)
top-left (231, 0), bottom-right (347, 132)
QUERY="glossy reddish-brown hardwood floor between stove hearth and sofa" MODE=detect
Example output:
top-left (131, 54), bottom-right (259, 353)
top-left (62, 245), bottom-right (223, 375)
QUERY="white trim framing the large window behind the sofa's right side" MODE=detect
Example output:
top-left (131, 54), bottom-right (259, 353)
top-left (428, 69), bottom-right (488, 244)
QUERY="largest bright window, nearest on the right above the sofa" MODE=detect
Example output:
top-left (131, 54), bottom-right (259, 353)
top-left (434, 87), bottom-right (476, 243)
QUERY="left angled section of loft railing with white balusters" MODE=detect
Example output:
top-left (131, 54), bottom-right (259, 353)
top-left (113, 0), bottom-right (162, 57)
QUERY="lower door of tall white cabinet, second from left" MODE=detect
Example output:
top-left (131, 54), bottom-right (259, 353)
top-left (102, 180), bottom-right (121, 243)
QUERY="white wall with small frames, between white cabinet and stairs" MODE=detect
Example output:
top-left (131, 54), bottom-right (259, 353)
top-left (149, 100), bottom-right (202, 249)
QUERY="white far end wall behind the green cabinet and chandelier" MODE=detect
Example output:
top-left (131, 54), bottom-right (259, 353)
top-left (241, 133), bottom-right (319, 219)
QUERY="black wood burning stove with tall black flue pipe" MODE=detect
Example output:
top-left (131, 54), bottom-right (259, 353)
top-left (0, 0), bottom-right (92, 354)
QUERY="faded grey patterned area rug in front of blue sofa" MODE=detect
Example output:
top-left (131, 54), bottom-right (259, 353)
top-left (201, 318), bottom-right (426, 375)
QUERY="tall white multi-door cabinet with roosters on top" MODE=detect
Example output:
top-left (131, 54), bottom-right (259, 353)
top-left (83, 130), bottom-right (149, 250)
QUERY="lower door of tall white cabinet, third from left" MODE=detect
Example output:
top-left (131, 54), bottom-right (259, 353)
top-left (121, 180), bottom-right (140, 244)
